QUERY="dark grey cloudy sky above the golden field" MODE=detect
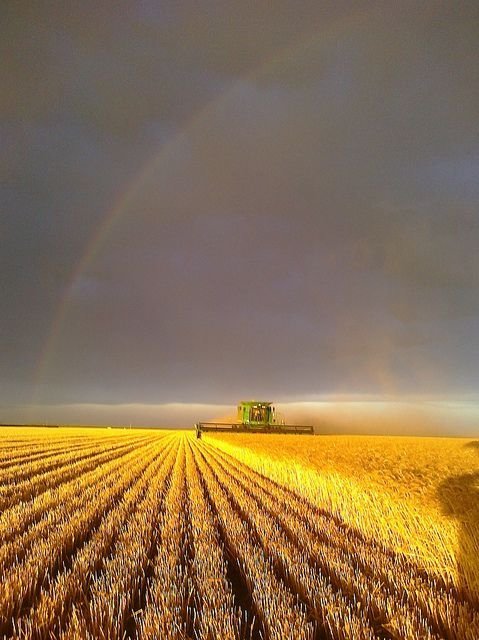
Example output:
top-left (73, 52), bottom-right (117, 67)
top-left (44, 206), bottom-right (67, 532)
top-left (0, 0), bottom-right (479, 430)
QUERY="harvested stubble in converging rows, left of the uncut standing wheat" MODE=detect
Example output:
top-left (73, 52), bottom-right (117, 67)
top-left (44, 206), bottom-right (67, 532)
top-left (0, 434), bottom-right (479, 640)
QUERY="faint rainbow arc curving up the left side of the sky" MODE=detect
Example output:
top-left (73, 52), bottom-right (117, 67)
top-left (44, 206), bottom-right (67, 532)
top-left (32, 8), bottom-right (375, 404)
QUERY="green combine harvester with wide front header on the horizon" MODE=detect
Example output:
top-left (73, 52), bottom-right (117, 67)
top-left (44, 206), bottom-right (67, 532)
top-left (195, 400), bottom-right (314, 438)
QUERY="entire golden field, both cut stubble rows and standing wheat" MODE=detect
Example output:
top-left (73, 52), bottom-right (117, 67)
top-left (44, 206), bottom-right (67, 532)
top-left (0, 428), bottom-right (479, 640)
